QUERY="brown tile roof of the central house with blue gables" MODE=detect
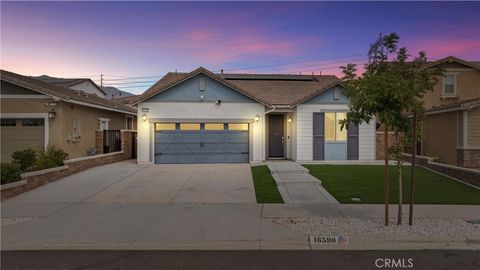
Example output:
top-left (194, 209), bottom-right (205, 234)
top-left (132, 67), bottom-right (340, 107)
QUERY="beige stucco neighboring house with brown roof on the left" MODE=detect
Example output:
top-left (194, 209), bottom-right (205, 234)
top-left (0, 70), bottom-right (137, 162)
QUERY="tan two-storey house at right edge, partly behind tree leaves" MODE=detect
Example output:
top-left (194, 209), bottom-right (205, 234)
top-left (417, 56), bottom-right (480, 168)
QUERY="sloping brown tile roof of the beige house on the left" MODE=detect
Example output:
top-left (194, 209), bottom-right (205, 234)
top-left (0, 70), bottom-right (136, 114)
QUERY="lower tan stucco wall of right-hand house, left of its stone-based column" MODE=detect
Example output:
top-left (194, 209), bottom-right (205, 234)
top-left (422, 112), bottom-right (457, 165)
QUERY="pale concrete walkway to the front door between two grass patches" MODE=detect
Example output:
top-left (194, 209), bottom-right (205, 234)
top-left (267, 161), bottom-right (338, 204)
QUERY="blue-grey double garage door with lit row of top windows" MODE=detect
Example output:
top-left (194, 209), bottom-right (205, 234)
top-left (155, 123), bottom-right (249, 164)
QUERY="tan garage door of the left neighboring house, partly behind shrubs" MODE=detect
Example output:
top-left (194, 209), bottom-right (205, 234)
top-left (1, 118), bottom-right (45, 162)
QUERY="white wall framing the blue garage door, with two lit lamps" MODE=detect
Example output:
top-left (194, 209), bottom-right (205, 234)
top-left (137, 102), bottom-right (265, 163)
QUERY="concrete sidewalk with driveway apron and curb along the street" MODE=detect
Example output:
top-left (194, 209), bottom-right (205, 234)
top-left (1, 203), bottom-right (480, 250)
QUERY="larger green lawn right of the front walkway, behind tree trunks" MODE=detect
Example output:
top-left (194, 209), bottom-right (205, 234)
top-left (304, 165), bottom-right (480, 204)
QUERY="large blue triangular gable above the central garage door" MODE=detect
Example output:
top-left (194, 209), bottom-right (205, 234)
top-left (146, 74), bottom-right (255, 102)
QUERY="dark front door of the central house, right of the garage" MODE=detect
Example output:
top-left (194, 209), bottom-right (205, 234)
top-left (268, 114), bottom-right (285, 158)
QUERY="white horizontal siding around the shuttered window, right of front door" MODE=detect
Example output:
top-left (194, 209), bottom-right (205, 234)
top-left (295, 104), bottom-right (375, 161)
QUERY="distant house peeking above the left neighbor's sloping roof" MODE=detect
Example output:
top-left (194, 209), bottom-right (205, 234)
top-left (33, 75), bottom-right (107, 98)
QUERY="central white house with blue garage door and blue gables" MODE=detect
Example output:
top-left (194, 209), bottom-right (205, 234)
top-left (132, 68), bottom-right (375, 163)
